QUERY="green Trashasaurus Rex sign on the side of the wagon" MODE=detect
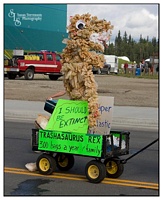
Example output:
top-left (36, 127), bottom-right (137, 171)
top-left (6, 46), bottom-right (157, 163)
top-left (38, 129), bottom-right (103, 157)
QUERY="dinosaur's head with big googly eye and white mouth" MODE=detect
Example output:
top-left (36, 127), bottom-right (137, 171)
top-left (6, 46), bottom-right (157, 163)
top-left (67, 13), bottom-right (113, 50)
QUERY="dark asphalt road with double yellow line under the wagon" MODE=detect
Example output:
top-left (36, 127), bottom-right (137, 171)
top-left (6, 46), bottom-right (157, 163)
top-left (4, 121), bottom-right (159, 196)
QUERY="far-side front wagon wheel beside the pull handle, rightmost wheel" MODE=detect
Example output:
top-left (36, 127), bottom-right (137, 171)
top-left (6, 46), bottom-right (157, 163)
top-left (104, 158), bottom-right (124, 178)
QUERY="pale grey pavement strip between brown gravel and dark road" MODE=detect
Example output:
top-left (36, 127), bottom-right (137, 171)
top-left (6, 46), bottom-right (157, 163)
top-left (4, 100), bottom-right (159, 130)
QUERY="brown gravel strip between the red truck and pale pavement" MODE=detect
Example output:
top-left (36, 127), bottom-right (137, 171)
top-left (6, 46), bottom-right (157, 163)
top-left (4, 75), bottom-right (159, 107)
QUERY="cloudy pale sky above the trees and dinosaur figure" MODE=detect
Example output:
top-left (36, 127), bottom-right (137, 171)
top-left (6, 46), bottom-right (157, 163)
top-left (67, 3), bottom-right (159, 42)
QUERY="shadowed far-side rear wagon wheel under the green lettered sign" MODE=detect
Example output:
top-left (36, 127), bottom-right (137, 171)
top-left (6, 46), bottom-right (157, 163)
top-left (55, 153), bottom-right (75, 171)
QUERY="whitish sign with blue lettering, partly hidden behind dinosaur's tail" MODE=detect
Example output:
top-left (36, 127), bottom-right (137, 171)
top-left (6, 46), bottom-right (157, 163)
top-left (89, 96), bottom-right (114, 135)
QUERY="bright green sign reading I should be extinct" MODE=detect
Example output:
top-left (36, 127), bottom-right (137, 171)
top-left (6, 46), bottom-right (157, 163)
top-left (46, 99), bottom-right (88, 133)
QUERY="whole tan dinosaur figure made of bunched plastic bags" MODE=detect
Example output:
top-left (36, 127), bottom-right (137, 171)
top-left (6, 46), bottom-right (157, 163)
top-left (61, 14), bottom-right (113, 128)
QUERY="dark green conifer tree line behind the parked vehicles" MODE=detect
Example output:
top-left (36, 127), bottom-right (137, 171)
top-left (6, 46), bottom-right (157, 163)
top-left (104, 30), bottom-right (159, 63)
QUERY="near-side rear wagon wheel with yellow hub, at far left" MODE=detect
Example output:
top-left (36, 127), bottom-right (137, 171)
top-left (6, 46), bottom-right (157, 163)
top-left (36, 153), bottom-right (56, 175)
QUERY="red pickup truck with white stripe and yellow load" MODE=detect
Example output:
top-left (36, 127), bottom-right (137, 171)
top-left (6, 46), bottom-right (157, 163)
top-left (4, 50), bottom-right (62, 80)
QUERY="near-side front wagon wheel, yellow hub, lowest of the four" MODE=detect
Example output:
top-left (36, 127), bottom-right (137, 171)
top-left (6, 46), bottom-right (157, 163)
top-left (85, 160), bottom-right (106, 183)
